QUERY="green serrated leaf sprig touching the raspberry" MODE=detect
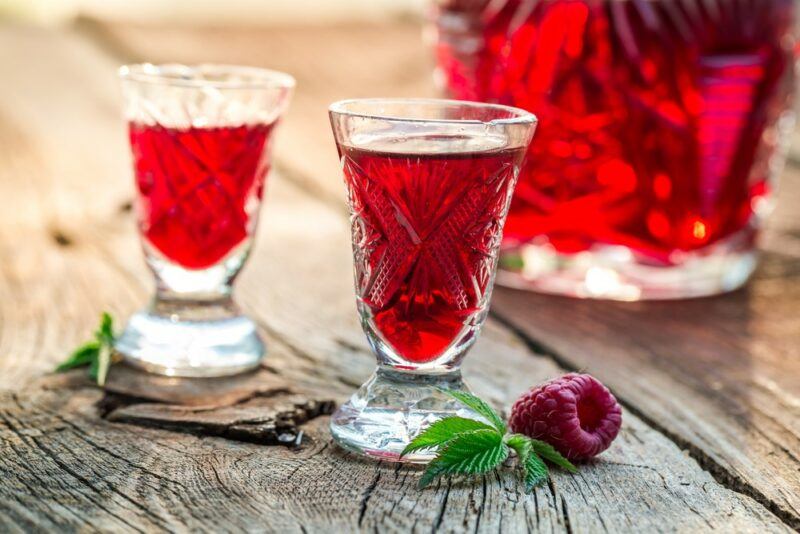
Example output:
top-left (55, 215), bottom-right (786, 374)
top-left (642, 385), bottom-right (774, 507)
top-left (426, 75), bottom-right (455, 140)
top-left (400, 390), bottom-right (577, 492)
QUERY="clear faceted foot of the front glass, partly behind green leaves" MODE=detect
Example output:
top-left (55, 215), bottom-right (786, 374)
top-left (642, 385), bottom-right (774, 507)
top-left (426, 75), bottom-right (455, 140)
top-left (331, 368), bottom-right (479, 463)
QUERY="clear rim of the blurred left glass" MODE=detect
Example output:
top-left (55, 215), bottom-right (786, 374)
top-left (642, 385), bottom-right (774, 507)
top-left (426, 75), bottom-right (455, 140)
top-left (117, 63), bottom-right (296, 89)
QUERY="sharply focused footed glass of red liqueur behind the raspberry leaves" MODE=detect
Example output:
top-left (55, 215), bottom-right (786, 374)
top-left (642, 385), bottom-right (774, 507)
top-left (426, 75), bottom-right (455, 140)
top-left (330, 99), bottom-right (536, 462)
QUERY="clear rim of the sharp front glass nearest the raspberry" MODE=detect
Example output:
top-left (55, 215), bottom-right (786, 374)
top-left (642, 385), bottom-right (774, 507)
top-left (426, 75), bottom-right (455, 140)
top-left (328, 98), bottom-right (539, 125)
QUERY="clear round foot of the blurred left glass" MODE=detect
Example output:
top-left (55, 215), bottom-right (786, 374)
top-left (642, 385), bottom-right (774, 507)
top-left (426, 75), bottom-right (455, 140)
top-left (115, 301), bottom-right (265, 377)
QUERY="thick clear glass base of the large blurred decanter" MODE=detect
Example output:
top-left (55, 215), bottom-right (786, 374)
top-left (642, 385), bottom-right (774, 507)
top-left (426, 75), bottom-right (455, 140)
top-left (497, 245), bottom-right (757, 301)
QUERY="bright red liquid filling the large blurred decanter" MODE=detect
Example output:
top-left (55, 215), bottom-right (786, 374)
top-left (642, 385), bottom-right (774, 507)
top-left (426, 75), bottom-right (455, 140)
top-left (437, 0), bottom-right (794, 265)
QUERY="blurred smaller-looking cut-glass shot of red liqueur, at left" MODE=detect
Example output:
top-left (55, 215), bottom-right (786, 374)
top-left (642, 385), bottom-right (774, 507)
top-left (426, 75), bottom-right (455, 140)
top-left (116, 64), bottom-right (294, 376)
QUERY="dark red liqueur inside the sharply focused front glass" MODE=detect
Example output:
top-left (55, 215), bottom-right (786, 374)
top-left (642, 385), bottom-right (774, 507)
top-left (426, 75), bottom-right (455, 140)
top-left (339, 139), bottom-right (524, 363)
